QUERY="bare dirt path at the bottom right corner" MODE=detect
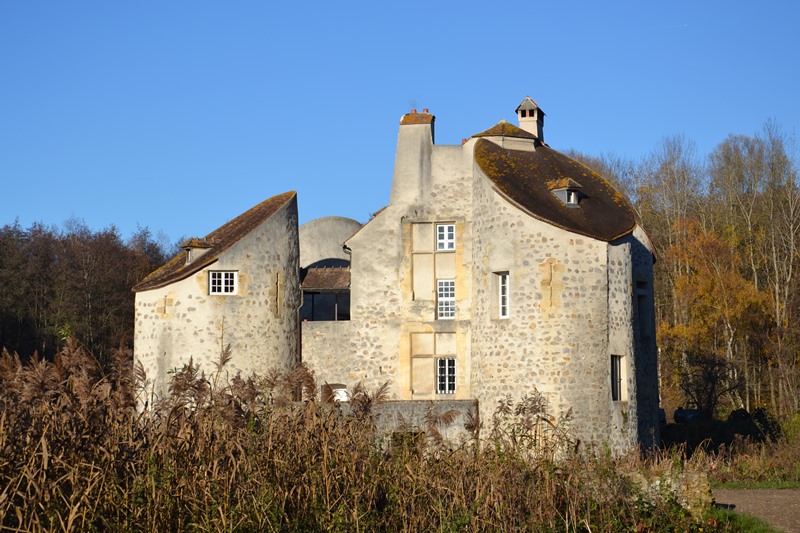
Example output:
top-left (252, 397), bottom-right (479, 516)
top-left (713, 489), bottom-right (800, 533)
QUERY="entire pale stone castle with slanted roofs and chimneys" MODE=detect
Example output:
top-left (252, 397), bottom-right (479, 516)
top-left (135, 98), bottom-right (658, 450)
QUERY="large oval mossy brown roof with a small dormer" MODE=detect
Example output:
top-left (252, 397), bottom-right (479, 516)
top-left (475, 137), bottom-right (636, 241)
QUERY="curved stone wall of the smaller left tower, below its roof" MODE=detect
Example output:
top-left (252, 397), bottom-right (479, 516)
top-left (134, 195), bottom-right (300, 396)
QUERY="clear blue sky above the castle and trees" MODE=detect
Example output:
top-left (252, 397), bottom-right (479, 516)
top-left (0, 0), bottom-right (800, 242)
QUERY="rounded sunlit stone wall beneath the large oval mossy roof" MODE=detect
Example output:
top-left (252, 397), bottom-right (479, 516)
top-left (472, 152), bottom-right (630, 442)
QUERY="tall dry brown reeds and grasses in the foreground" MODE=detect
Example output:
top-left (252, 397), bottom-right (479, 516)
top-left (0, 341), bottom-right (792, 531)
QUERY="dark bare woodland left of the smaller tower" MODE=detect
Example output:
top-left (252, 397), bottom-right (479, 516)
top-left (0, 219), bottom-right (172, 368)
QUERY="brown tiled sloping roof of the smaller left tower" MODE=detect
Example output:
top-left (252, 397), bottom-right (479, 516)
top-left (133, 191), bottom-right (296, 292)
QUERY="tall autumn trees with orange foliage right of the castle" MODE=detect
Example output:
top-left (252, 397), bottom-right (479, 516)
top-left (573, 121), bottom-right (800, 415)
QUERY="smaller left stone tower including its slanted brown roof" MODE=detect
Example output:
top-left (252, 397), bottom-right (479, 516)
top-left (133, 192), bottom-right (300, 396)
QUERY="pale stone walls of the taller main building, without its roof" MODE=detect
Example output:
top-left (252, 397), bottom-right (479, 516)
top-left (303, 118), bottom-right (657, 451)
